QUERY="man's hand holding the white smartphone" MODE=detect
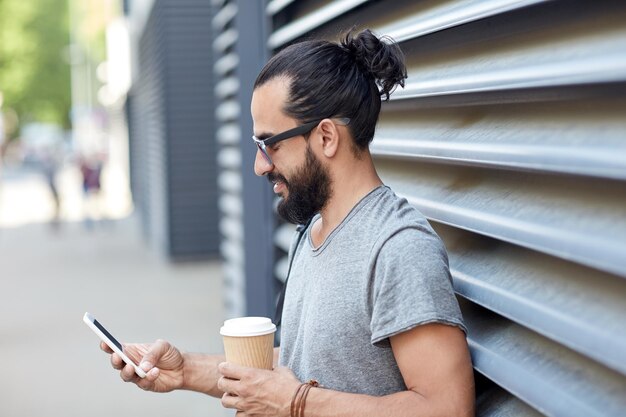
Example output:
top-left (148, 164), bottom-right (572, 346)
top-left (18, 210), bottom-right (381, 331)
top-left (100, 340), bottom-right (185, 392)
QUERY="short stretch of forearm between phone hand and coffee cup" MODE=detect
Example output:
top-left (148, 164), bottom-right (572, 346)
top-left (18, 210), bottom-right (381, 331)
top-left (182, 353), bottom-right (226, 398)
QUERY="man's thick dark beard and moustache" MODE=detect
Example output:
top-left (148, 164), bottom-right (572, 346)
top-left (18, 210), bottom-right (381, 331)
top-left (267, 145), bottom-right (331, 224)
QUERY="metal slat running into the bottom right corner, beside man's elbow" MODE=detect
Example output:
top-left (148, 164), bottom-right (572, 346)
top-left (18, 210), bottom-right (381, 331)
top-left (462, 304), bottom-right (626, 417)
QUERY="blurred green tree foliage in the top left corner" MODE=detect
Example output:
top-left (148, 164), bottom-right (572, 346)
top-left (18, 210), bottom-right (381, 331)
top-left (0, 0), bottom-right (71, 135)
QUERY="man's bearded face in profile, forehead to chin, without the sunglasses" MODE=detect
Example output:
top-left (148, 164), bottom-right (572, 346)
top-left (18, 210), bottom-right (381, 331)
top-left (251, 79), bottom-right (331, 224)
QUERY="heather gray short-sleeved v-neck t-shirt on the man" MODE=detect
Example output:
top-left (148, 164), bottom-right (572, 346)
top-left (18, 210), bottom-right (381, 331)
top-left (279, 186), bottom-right (465, 395)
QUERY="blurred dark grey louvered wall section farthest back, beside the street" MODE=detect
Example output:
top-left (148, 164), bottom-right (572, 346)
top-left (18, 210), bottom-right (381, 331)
top-left (128, 0), bottom-right (219, 260)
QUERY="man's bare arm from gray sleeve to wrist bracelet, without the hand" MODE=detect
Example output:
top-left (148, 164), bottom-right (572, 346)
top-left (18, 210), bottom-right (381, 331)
top-left (306, 324), bottom-right (474, 417)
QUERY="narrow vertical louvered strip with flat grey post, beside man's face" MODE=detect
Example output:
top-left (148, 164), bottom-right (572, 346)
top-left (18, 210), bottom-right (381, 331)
top-left (212, 0), bottom-right (276, 317)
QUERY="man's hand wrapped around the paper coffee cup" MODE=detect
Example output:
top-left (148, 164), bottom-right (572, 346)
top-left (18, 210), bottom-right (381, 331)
top-left (217, 362), bottom-right (300, 417)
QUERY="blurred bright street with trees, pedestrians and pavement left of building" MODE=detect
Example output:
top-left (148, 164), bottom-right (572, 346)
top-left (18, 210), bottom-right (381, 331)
top-left (0, 0), bottom-right (228, 417)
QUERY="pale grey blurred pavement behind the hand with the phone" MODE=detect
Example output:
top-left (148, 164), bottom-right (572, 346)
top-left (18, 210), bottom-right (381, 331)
top-left (0, 166), bottom-right (231, 417)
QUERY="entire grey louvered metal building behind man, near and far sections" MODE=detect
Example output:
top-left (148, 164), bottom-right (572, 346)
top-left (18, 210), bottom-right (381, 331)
top-left (127, 0), bottom-right (626, 417)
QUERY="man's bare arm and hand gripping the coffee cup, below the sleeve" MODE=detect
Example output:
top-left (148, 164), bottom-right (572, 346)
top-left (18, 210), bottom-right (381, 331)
top-left (218, 324), bottom-right (474, 417)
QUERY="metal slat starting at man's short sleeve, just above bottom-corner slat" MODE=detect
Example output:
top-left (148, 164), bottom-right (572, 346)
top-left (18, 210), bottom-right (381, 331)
top-left (435, 224), bottom-right (626, 373)
